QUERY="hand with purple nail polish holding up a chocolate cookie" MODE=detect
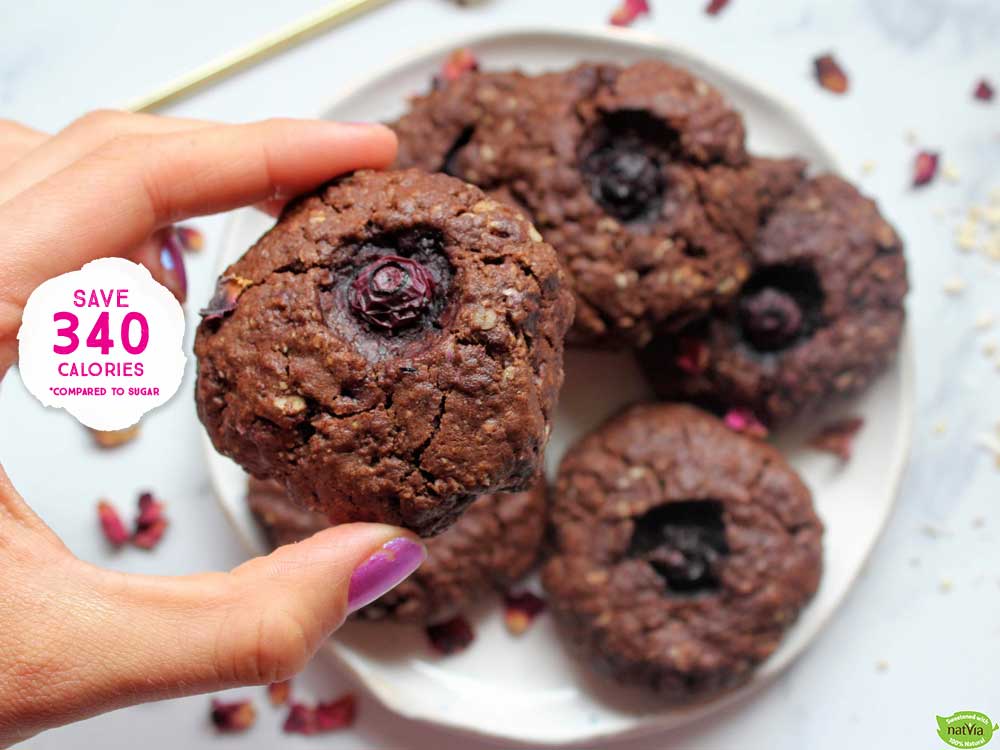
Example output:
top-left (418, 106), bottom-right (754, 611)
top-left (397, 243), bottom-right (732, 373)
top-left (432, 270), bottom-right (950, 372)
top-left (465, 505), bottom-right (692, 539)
top-left (0, 112), bottom-right (424, 747)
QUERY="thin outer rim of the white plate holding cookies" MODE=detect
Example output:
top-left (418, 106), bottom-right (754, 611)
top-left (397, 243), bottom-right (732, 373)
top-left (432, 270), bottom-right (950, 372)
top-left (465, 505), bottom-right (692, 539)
top-left (201, 24), bottom-right (915, 748)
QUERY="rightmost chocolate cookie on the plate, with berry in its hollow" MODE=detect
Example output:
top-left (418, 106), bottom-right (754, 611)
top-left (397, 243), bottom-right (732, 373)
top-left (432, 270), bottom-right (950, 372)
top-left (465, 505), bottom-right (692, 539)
top-left (640, 175), bottom-right (907, 424)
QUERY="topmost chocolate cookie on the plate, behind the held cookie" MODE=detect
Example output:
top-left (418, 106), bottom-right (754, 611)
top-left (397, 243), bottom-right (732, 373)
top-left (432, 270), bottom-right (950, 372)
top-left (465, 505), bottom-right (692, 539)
top-left (393, 60), bottom-right (803, 346)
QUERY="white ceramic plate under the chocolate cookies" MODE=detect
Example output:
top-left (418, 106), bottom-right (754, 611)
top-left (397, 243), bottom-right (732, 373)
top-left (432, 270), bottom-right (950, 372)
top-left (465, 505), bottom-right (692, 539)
top-left (205, 29), bottom-right (912, 745)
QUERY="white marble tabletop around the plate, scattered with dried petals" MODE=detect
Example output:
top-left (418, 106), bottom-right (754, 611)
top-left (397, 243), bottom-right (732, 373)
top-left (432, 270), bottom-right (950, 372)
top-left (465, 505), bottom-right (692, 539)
top-left (0, 0), bottom-right (1000, 750)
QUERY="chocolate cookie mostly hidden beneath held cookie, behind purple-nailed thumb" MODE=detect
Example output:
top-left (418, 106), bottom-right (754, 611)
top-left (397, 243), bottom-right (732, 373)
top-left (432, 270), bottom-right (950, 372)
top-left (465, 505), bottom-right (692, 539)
top-left (247, 479), bottom-right (546, 625)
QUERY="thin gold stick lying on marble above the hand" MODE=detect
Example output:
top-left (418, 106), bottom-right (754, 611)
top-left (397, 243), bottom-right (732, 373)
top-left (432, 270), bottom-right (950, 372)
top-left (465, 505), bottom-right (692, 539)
top-left (126, 0), bottom-right (389, 112)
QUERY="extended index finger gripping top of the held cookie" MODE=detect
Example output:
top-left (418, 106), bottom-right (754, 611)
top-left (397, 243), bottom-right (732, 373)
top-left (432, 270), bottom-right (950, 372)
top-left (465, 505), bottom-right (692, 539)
top-left (0, 120), bottom-right (396, 314)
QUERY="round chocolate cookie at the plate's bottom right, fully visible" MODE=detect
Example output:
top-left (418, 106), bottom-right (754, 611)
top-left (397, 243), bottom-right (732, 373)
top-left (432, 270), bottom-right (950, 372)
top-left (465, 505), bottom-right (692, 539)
top-left (542, 404), bottom-right (822, 702)
